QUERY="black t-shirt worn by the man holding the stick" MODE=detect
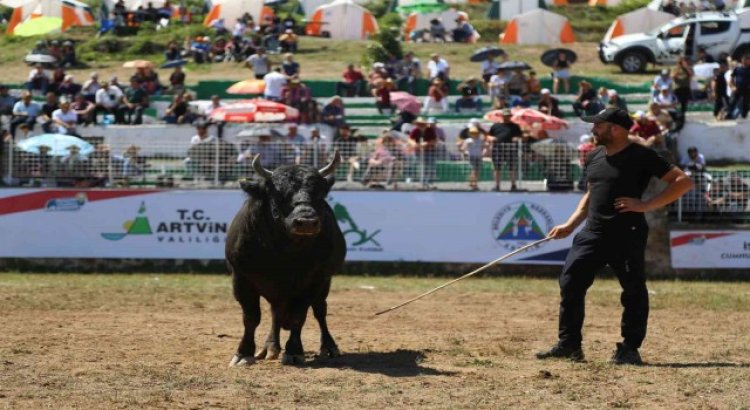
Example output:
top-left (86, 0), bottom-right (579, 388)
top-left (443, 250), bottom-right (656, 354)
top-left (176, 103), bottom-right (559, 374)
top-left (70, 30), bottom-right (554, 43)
top-left (584, 143), bottom-right (672, 232)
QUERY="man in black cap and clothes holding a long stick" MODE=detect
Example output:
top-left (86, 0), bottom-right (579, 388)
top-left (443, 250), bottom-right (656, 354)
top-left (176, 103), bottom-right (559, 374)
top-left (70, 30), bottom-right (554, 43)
top-left (536, 108), bottom-right (693, 365)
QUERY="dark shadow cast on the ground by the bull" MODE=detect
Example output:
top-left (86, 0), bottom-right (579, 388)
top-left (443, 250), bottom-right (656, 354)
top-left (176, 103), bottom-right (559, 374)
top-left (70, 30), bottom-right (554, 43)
top-left (308, 349), bottom-right (455, 377)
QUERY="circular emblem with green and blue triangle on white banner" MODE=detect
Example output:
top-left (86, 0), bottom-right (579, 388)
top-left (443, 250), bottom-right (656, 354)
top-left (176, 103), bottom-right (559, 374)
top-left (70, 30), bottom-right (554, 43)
top-left (491, 202), bottom-right (553, 251)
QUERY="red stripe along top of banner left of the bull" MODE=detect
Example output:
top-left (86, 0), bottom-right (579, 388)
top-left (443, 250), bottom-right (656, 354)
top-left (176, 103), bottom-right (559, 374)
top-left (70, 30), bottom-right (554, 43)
top-left (0, 189), bottom-right (162, 215)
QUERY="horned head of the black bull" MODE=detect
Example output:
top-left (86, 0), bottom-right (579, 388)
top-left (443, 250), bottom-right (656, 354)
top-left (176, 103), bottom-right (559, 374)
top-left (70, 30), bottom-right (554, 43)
top-left (240, 150), bottom-right (341, 237)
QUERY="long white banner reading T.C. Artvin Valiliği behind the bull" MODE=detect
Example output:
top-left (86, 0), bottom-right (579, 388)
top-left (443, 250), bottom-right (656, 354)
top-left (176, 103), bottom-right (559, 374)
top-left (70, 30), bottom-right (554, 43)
top-left (0, 189), bottom-right (580, 264)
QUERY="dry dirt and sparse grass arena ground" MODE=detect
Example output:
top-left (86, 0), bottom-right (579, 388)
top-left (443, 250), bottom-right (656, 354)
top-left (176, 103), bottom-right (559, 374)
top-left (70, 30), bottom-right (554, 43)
top-left (0, 274), bottom-right (750, 409)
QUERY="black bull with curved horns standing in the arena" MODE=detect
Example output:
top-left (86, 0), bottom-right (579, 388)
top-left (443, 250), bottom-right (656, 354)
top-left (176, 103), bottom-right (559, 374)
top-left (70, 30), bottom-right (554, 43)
top-left (226, 152), bottom-right (346, 366)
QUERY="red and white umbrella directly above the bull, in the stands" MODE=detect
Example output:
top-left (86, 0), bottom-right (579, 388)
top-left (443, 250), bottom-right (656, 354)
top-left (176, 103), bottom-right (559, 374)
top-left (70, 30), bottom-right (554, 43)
top-left (211, 99), bottom-right (299, 122)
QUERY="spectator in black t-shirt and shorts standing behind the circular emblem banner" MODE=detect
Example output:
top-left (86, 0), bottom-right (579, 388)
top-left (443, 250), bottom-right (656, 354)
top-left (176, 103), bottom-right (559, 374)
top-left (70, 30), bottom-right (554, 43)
top-left (490, 108), bottom-right (523, 191)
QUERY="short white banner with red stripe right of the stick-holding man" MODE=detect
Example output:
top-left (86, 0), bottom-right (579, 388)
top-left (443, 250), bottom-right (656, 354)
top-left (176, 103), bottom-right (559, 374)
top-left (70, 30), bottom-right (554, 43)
top-left (669, 229), bottom-right (750, 269)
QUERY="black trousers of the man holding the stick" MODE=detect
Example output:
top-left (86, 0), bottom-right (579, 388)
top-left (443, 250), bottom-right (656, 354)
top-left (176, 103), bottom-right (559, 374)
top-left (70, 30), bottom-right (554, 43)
top-left (559, 224), bottom-right (648, 348)
